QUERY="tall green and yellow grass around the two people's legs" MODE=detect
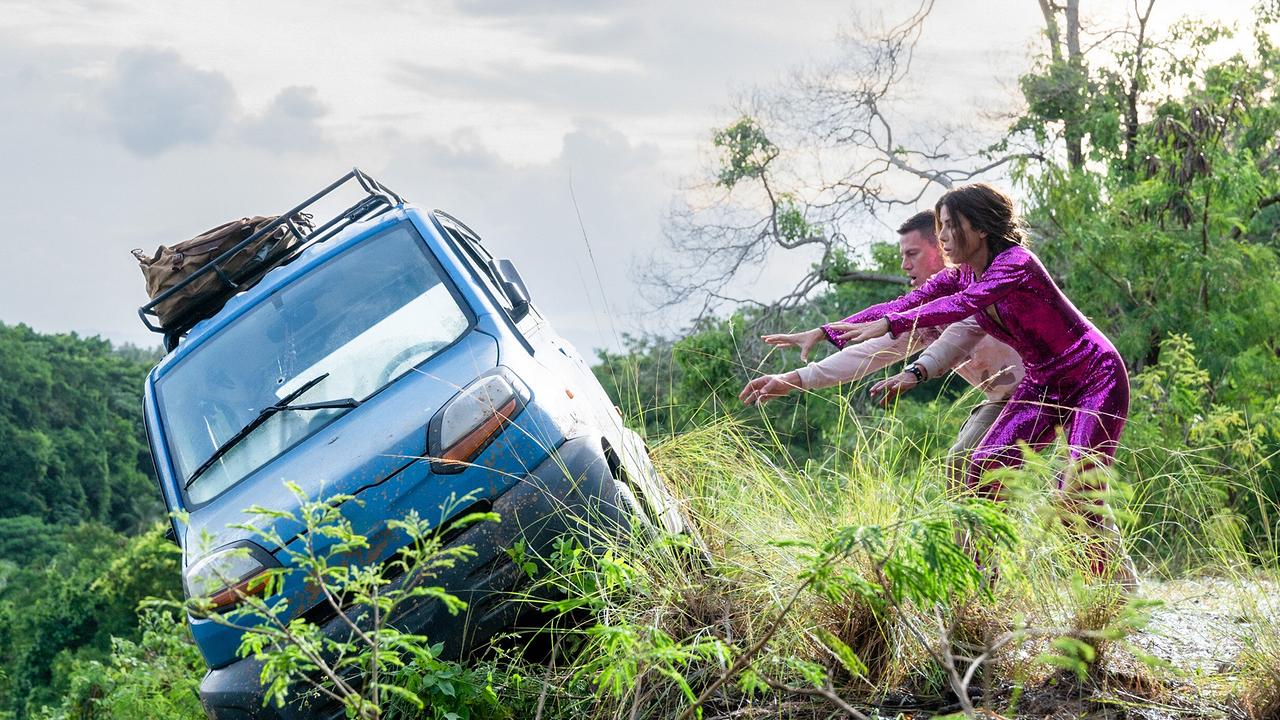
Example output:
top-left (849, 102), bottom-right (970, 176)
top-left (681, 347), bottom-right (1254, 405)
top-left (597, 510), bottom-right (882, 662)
top-left (513, 386), bottom-right (1280, 717)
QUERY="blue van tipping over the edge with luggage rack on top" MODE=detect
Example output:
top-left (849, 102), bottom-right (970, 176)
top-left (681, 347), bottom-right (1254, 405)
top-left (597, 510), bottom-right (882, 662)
top-left (140, 169), bottom-right (687, 720)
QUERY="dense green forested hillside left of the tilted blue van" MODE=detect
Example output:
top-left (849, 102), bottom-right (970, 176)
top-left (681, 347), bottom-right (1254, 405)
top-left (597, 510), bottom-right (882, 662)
top-left (0, 325), bottom-right (180, 716)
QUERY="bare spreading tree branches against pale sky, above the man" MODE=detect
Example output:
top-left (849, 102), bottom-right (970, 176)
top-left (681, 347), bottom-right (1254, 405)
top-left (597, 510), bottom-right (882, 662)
top-left (641, 0), bottom-right (1034, 319)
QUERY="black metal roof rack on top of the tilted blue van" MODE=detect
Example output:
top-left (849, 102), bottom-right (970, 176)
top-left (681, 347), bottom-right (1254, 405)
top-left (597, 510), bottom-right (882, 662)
top-left (138, 168), bottom-right (404, 350)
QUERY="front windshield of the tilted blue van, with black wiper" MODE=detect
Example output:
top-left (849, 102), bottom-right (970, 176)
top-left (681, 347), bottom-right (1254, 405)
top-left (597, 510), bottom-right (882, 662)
top-left (156, 222), bottom-right (470, 505)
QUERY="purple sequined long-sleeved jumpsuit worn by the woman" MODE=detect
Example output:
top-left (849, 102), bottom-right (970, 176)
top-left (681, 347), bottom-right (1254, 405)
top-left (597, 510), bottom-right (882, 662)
top-left (826, 246), bottom-right (1129, 509)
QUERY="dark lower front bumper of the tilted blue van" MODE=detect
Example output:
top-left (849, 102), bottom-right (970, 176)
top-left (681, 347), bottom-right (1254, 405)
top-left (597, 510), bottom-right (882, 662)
top-left (200, 436), bottom-right (631, 720)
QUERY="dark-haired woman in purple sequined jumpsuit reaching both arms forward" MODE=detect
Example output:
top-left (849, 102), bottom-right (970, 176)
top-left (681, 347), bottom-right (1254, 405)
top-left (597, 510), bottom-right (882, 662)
top-left (828, 183), bottom-right (1132, 582)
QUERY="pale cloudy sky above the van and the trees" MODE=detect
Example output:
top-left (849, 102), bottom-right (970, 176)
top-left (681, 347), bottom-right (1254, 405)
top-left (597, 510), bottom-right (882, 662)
top-left (0, 0), bottom-right (1249, 354)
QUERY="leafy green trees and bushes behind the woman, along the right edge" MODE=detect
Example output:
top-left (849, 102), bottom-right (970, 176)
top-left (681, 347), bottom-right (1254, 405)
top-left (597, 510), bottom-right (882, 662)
top-left (998, 3), bottom-right (1280, 556)
